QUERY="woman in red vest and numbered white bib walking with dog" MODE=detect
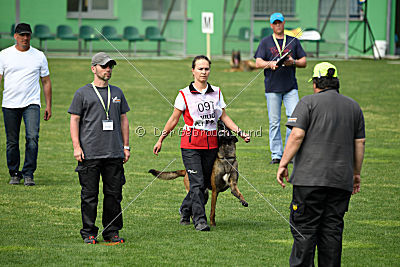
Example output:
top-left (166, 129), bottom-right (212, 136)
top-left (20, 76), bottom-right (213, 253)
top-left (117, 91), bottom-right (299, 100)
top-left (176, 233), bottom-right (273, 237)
top-left (153, 55), bottom-right (250, 231)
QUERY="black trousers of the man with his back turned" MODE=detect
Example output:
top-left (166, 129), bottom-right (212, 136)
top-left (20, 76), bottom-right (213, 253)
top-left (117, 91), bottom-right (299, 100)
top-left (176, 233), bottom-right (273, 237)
top-left (289, 186), bottom-right (351, 267)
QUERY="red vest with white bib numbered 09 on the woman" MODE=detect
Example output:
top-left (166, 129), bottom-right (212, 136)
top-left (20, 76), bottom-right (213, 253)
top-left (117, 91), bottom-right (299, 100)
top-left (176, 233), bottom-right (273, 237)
top-left (179, 83), bottom-right (222, 149)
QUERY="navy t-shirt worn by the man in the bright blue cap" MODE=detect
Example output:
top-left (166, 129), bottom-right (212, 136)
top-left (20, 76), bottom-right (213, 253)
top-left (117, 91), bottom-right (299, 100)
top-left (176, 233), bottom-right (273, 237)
top-left (254, 35), bottom-right (306, 93)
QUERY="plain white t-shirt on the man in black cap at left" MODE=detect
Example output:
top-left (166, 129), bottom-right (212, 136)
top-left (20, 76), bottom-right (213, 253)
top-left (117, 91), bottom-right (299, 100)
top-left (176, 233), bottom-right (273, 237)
top-left (0, 46), bottom-right (50, 108)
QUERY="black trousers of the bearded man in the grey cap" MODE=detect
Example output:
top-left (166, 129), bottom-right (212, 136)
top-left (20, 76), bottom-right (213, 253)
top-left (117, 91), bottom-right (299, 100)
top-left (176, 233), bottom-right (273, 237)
top-left (75, 159), bottom-right (125, 239)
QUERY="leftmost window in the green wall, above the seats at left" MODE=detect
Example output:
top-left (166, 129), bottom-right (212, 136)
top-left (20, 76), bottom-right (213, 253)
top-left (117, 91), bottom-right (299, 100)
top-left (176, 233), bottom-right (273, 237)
top-left (67, 0), bottom-right (114, 19)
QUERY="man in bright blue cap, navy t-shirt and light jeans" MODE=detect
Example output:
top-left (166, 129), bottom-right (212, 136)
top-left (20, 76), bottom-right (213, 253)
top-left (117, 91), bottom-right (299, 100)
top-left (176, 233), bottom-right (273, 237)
top-left (254, 13), bottom-right (307, 164)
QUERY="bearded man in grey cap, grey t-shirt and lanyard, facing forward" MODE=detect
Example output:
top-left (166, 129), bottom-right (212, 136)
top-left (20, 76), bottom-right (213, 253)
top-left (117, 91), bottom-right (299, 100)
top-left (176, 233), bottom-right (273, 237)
top-left (68, 52), bottom-right (130, 244)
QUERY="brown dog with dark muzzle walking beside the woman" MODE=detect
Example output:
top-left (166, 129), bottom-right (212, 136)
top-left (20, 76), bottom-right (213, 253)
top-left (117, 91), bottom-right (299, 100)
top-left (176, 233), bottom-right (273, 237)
top-left (149, 120), bottom-right (249, 226)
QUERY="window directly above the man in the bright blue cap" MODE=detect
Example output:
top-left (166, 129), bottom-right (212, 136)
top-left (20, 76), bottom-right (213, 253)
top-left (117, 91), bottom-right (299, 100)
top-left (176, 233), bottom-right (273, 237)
top-left (254, 0), bottom-right (296, 18)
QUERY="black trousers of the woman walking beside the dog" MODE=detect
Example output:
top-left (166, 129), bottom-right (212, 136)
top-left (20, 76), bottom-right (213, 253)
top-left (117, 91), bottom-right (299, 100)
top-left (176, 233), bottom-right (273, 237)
top-left (180, 148), bottom-right (218, 226)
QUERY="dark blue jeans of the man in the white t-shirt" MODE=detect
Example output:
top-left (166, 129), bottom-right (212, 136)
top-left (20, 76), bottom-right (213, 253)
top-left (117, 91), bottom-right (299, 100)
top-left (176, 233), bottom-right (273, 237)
top-left (2, 105), bottom-right (40, 178)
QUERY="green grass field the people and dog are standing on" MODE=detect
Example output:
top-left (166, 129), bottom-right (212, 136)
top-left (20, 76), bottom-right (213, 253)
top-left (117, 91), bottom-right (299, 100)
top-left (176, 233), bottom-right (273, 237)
top-left (0, 59), bottom-right (400, 266)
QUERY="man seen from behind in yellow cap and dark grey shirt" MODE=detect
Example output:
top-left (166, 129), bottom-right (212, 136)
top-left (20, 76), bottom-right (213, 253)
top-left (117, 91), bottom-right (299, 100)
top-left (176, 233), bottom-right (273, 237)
top-left (277, 62), bottom-right (365, 266)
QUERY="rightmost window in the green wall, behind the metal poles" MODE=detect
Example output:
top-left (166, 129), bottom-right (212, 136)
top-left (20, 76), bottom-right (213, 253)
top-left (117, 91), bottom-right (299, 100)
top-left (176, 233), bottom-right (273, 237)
top-left (321, 0), bottom-right (361, 18)
